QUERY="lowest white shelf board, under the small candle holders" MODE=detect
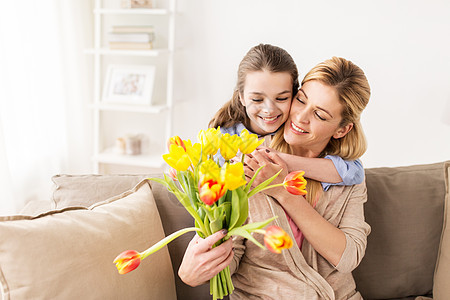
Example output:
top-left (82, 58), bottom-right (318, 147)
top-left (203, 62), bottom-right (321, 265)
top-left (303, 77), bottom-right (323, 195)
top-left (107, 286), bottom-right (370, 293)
top-left (93, 150), bottom-right (164, 168)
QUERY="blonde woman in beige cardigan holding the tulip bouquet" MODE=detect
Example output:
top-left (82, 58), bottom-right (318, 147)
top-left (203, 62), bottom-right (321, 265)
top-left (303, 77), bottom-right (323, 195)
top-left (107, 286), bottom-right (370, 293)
top-left (179, 57), bottom-right (370, 299)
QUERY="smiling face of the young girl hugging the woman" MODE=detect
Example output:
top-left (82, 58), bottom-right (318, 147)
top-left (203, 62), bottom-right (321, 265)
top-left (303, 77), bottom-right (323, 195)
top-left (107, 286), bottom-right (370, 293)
top-left (239, 70), bottom-right (293, 135)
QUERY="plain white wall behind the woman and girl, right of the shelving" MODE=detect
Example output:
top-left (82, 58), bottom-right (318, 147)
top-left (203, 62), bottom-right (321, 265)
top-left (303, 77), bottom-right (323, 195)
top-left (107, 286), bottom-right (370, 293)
top-left (171, 0), bottom-right (450, 167)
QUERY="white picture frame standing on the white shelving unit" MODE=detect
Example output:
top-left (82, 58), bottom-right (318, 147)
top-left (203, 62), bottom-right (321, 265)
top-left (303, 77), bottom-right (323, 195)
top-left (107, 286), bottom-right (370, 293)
top-left (102, 65), bottom-right (156, 105)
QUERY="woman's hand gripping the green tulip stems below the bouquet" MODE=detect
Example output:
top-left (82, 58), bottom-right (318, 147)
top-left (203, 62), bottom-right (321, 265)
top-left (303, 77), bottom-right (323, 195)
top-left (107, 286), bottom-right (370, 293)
top-left (178, 230), bottom-right (234, 286)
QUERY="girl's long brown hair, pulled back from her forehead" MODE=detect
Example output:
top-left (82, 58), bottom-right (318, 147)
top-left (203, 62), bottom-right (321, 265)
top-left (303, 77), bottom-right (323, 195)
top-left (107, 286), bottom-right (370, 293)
top-left (208, 44), bottom-right (299, 128)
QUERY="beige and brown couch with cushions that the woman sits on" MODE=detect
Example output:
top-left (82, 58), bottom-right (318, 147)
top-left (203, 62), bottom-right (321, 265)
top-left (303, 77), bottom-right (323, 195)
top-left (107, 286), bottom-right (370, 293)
top-left (0, 161), bottom-right (450, 300)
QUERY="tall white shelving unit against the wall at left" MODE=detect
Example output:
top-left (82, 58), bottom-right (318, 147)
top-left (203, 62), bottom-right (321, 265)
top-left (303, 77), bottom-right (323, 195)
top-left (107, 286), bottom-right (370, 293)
top-left (85, 0), bottom-right (176, 174)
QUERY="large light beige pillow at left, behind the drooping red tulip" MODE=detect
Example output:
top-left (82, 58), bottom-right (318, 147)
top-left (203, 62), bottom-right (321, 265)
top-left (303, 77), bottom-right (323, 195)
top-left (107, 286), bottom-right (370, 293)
top-left (0, 180), bottom-right (176, 300)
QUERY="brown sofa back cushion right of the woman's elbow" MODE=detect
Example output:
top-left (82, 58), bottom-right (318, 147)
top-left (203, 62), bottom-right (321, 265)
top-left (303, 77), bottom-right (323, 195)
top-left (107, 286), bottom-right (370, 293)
top-left (354, 163), bottom-right (445, 299)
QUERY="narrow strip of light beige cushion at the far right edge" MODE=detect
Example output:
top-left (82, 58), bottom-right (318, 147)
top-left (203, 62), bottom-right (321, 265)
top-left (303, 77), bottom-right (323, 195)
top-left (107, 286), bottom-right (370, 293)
top-left (433, 162), bottom-right (450, 300)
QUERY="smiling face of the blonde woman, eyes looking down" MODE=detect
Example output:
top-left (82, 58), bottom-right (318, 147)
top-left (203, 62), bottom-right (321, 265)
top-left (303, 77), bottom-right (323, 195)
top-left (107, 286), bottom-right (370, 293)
top-left (284, 80), bottom-right (353, 157)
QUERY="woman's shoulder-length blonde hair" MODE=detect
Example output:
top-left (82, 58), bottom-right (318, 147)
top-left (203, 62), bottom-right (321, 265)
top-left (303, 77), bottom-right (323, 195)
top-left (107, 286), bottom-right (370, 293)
top-left (271, 57), bottom-right (370, 203)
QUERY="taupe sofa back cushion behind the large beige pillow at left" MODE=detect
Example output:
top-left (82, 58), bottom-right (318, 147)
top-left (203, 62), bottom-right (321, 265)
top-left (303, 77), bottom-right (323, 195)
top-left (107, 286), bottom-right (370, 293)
top-left (49, 173), bottom-right (211, 300)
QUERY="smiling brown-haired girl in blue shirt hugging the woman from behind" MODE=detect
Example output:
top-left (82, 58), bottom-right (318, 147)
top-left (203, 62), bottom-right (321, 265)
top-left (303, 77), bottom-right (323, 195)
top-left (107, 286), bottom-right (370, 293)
top-left (209, 44), bottom-right (364, 190)
